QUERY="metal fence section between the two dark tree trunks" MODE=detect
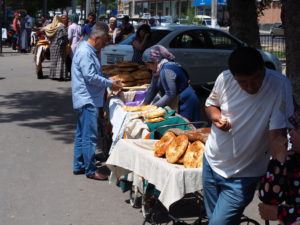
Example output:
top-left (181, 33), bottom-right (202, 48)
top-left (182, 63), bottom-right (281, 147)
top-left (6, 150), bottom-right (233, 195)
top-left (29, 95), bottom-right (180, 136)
top-left (260, 34), bottom-right (285, 61)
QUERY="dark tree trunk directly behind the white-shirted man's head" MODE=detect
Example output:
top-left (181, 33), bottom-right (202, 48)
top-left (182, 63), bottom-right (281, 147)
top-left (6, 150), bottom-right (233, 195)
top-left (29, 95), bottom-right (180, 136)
top-left (227, 0), bottom-right (260, 48)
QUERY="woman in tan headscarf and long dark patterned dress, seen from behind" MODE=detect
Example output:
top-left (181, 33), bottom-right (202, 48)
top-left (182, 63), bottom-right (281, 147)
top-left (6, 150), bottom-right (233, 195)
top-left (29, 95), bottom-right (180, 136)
top-left (43, 16), bottom-right (68, 80)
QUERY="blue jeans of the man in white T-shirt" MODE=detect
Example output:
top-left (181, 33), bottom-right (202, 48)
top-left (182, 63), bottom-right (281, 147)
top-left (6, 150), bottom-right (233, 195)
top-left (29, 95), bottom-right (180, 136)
top-left (202, 156), bottom-right (259, 225)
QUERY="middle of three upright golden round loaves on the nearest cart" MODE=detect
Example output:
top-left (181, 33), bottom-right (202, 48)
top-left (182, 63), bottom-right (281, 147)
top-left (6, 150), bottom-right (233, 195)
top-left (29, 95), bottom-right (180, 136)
top-left (166, 135), bottom-right (189, 163)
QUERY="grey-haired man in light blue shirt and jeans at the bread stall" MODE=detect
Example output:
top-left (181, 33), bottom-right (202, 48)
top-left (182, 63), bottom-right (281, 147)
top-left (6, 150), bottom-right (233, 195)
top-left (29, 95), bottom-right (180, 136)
top-left (72, 23), bottom-right (120, 180)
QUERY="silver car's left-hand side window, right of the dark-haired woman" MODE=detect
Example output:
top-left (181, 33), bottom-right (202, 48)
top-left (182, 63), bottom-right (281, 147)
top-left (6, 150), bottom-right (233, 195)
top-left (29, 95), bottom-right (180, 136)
top-left (170, 30), bottom-right (206, 48)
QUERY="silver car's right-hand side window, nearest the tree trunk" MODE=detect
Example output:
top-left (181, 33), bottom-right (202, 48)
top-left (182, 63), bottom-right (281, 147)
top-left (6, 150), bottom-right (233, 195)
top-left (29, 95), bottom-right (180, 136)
top-left (206, 30), bottom-right (239, 50)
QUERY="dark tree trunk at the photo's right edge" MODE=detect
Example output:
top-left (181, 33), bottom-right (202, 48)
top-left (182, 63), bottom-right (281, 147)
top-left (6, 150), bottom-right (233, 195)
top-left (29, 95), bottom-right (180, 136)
top-left (281, 0), bottom-right (300, 104)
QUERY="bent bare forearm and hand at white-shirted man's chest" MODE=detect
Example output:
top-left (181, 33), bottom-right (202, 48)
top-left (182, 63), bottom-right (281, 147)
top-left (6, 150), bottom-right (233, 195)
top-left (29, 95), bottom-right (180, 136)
top-left (205, 106), bottom-right (231, 131)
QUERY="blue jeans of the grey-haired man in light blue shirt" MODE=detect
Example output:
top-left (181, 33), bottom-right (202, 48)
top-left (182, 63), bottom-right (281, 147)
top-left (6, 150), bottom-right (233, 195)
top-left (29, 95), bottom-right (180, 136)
top-left (73, 104), bottom-right (99, 175)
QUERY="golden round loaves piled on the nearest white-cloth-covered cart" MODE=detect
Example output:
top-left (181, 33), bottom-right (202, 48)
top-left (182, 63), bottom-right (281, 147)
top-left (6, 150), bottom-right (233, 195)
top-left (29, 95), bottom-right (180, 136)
top-left (154, 128), bottom-right (210, 168)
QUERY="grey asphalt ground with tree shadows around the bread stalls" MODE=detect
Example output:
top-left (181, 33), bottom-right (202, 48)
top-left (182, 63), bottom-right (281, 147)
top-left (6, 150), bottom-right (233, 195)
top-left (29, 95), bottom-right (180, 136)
top-left (0, 53), bottom-right (275, 225)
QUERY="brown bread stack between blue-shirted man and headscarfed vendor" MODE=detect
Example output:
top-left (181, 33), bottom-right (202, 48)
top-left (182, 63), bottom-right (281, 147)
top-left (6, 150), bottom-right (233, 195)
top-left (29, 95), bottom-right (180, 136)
top-left (102, 61), bottom-right (151, 87)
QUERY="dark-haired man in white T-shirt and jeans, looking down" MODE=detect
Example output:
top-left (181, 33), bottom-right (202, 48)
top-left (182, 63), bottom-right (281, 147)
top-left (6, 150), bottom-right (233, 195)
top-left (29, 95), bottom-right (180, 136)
top-left (203, 47), bottom-right (293, 225)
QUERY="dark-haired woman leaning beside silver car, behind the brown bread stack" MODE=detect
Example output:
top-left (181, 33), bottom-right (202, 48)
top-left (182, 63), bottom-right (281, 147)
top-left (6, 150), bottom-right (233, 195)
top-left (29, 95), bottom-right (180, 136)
top-left (132, 24), bottom-right (151, 64)
